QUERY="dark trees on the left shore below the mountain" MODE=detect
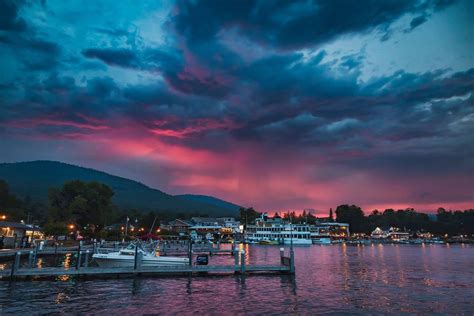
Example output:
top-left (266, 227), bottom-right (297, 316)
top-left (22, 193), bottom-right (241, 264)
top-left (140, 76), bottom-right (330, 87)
top-left (0, 180), bottom-right (209, 237)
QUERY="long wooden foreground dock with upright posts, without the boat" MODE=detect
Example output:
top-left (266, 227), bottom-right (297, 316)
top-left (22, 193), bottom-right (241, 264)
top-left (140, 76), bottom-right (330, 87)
top-left (0, 248), bottom-right (295, 280)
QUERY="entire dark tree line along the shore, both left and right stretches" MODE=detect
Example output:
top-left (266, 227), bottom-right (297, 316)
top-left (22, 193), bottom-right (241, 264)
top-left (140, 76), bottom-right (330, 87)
top-left (0, 180), bottom-right (474, 236)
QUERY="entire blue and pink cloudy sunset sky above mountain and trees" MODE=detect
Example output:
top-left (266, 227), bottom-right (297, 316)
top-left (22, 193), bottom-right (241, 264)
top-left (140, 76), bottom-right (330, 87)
top-left (0, 0), bottom-right (474, 212)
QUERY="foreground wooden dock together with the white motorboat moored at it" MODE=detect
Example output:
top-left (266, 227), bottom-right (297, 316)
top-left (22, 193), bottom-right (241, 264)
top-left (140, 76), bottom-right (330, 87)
top-left (0, 241), bottom-right (295, 280)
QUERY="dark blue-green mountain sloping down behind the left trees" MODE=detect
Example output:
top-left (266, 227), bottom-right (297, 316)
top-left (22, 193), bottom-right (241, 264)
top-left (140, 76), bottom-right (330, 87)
top-left (0, 161), bottom-right (238, 216)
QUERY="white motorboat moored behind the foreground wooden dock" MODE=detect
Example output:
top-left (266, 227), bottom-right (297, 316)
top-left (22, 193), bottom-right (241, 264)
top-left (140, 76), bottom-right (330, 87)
top-left (92, 242), bottom-right (189, 268)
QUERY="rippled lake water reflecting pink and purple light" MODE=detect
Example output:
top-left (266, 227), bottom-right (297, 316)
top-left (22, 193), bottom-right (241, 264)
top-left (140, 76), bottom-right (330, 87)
top-left (0, 244), bottom-right (474, 315)
